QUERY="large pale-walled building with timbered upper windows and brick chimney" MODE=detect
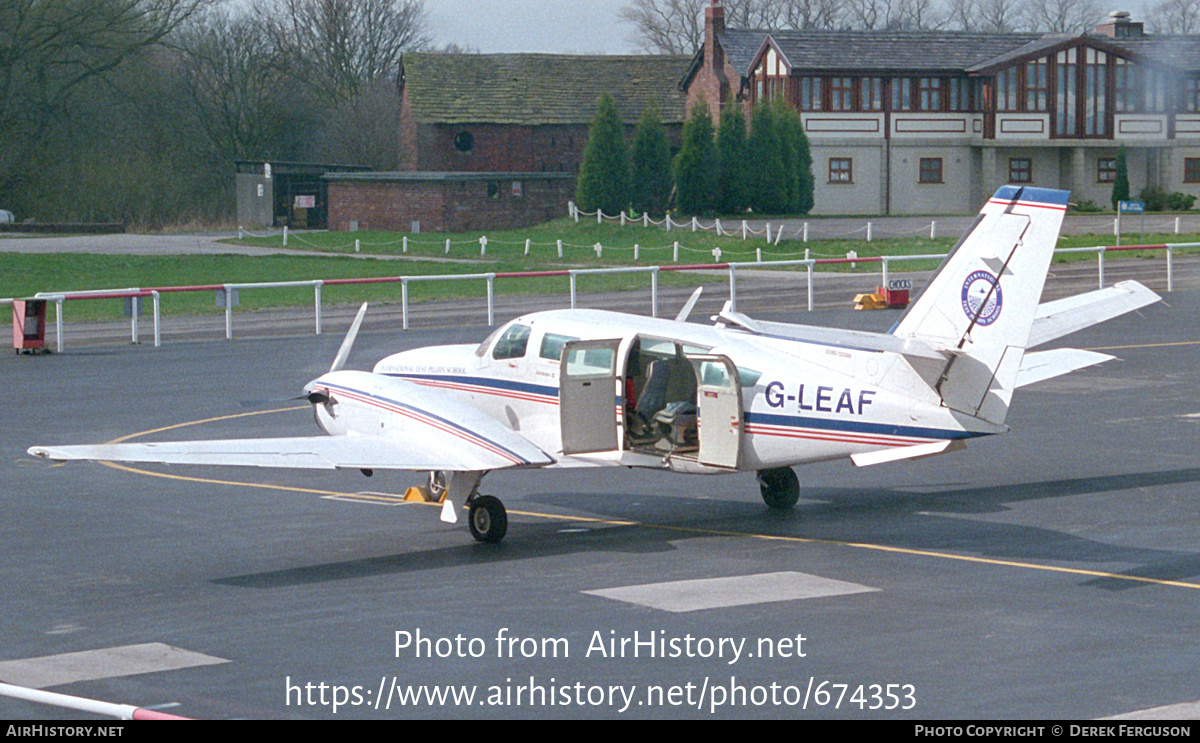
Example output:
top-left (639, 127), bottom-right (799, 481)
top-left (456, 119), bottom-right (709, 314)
top-left (683, 0), bottom-right (1200, 214)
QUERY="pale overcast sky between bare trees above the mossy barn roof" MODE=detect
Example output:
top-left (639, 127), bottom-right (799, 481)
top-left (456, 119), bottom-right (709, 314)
top-left (425, 0), bottom-right (640, 54)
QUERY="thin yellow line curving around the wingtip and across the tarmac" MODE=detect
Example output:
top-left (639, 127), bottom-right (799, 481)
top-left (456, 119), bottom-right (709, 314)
top-left (100, 408), bottom-right (1200, 591)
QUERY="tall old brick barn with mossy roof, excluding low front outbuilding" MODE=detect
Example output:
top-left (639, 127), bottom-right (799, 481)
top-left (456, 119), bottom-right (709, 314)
top-left (400, 53), bottom-right (690, 173)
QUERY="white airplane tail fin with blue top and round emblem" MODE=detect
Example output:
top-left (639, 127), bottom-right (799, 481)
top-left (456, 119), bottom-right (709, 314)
top-left (892, 186), bottom-right (1068, 424)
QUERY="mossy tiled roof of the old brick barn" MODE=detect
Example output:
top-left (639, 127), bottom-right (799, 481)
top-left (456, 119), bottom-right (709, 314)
top-left (402, 53), bottom-right (691, 125)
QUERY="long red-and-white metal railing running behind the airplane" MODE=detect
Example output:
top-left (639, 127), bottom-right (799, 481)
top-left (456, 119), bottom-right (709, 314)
top-left (14, 242), bottom-right (1200, 353)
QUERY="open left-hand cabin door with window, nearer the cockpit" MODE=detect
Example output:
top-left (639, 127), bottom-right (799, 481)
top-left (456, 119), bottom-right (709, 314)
top-left (558, 338), bottom-right (620, 454)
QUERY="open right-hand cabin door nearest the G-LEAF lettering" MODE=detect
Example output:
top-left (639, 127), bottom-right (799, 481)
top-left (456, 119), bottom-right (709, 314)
top-left (686, 353), bottom-right (742, 469)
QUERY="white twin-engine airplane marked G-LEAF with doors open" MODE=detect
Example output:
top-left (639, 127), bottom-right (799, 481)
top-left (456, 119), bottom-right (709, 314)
top-left (29, 186), bottom-right (1159, 541)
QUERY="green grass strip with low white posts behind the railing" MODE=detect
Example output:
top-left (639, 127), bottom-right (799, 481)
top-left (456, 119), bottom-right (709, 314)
top-left (0, 220), bottom-right (1200, 319)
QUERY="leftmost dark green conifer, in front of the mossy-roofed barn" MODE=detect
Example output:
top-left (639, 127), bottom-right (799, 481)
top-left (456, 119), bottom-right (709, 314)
top-left (575, 92), bottom-right (630, 215)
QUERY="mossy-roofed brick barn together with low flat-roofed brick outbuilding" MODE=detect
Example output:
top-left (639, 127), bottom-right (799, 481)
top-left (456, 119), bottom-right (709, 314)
top-left (326, 53), bottom-right (691, 232)
